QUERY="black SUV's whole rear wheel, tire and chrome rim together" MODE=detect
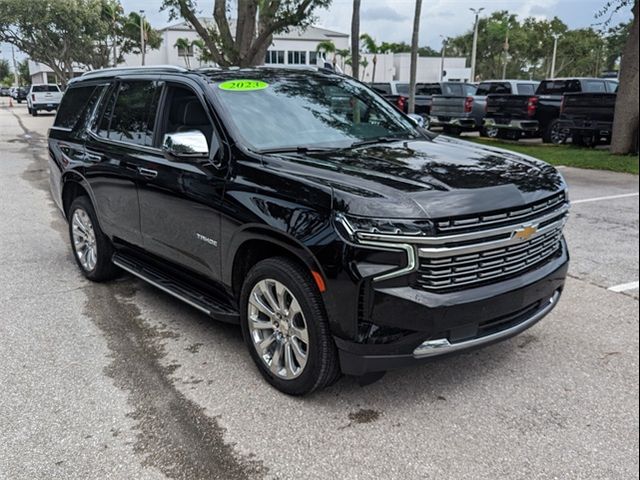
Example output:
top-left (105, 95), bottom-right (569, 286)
top-left (69, 196), bottom-right (120, 282)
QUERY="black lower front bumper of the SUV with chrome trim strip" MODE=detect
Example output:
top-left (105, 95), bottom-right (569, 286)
top-left (335, 242), bottom-right (569, 376)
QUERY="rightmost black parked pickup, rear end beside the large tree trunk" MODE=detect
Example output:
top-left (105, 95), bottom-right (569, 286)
top-left (560, 93), bottom-right (617, 147)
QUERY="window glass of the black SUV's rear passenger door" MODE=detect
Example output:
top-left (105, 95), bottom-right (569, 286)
top-left (96, 81), bottom-right (162, 147)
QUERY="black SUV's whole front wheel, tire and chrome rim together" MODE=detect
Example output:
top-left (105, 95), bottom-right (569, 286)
top-left (240, 257), bottom-right (340, 396)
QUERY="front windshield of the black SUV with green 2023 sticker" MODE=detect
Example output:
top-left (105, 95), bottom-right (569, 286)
top-left (213, 71), bottom-right (420, 151)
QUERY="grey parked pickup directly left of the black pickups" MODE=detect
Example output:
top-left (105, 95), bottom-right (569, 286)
top-left (430, 80), bottom-right (540, 136)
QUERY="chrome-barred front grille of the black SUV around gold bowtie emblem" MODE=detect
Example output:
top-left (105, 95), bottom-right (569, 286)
top-left (416, 193), bottom-right (568, 293)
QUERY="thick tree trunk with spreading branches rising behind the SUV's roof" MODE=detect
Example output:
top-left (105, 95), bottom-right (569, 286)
top-left (163, 0), bottom-right (331, 67)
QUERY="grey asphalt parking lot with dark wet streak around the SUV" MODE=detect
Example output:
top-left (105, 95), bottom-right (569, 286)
top-left (0, 99), bottom-right (639, 480)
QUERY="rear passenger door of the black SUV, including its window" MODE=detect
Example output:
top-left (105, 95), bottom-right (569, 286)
top-left (85, 78), bottom-right (162, 246)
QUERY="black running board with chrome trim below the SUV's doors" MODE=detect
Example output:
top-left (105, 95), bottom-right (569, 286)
top-left (111, 253), bottom-right (240, 323)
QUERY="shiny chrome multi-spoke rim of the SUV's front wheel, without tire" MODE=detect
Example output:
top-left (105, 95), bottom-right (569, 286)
top-left (247, 279), bottom-right (309, 380)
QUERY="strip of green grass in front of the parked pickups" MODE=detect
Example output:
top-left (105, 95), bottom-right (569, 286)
top-left (466, 137), bottom-right (638, 175)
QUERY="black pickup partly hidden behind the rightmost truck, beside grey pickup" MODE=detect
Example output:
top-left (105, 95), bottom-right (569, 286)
top-left (484, 78), bottom-right (618, 143)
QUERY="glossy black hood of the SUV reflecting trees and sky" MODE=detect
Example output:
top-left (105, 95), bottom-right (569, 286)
top-left (265, 136), bottom-right (565, 218)
